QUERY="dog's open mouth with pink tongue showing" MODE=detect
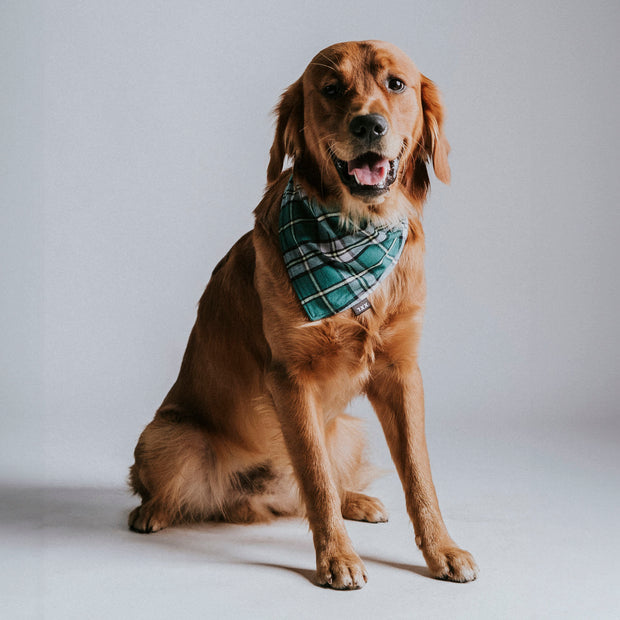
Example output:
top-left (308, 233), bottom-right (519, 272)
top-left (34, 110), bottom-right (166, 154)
top-left (332, 152), bottom-right (400, 197)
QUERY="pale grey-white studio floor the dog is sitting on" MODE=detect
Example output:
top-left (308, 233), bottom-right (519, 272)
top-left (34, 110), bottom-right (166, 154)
top-left (0, 423), bottom-right (620, 620)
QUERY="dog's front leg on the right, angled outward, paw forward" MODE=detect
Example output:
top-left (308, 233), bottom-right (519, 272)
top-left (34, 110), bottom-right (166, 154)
top-left (368, 359), bottom-right (478, 582)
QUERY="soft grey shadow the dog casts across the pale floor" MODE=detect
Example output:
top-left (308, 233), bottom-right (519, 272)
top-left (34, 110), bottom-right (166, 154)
top-left (0, 484), bottom-right (430, 583)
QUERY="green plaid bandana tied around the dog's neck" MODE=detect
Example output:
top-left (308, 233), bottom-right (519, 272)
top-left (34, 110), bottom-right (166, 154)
top-left (279, 177), bottom-right (408, 321)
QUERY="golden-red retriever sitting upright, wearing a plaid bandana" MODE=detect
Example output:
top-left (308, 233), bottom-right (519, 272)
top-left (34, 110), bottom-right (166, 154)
top-left (129, 41), bottom-right (478, 589)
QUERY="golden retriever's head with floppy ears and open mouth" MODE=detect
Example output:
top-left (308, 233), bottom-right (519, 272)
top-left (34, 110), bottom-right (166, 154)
top-left (267, 41), bottom-right (450, 220)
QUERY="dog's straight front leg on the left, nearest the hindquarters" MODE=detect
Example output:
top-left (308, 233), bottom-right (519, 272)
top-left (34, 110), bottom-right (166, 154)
top-left (268, 364), bottom-right (367, 590)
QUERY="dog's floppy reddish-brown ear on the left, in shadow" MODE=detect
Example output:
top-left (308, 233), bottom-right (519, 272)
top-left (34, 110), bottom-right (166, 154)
top-left (267, 78), bottom-right (304, 183)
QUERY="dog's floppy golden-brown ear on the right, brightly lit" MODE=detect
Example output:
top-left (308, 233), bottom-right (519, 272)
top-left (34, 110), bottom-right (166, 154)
top-left (404, 75), bottom-right (450, 200)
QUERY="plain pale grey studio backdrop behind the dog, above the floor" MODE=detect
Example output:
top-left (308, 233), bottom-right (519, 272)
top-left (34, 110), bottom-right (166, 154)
top-left (0, 0), bottom-right (620, 484)
